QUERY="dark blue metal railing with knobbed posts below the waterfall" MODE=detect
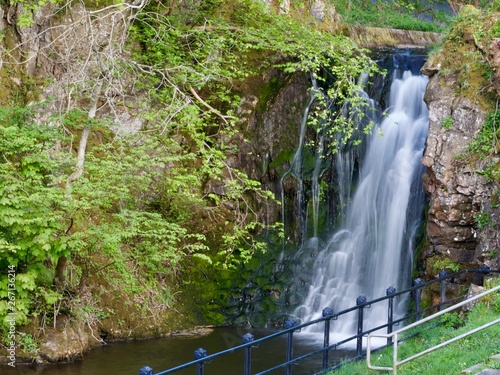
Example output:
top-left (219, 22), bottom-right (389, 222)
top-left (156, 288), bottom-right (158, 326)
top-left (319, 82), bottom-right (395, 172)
top-left (139, 267), bottom-right (500, 375)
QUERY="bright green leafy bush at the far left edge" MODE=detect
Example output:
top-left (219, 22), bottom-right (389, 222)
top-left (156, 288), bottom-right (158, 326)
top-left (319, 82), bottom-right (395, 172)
top-left (0, 108), bottom-right (71, 324)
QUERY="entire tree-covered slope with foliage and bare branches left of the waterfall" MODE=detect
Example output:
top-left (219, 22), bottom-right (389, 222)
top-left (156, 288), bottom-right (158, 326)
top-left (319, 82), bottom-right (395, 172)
top-left (0, 0), bottom-right (374, 358)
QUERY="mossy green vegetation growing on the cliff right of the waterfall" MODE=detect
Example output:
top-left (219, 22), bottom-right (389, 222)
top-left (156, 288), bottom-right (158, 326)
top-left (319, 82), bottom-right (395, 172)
top-left (428, 1), bottom-right (500, 244)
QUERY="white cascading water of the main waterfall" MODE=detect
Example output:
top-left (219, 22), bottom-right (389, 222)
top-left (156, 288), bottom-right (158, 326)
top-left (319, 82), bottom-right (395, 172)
top-left (295, 71), bottom-right (428, 335)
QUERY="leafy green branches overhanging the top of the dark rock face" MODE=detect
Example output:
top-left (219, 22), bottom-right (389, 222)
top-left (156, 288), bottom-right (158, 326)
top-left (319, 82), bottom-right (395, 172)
top-left (134, 0), bottom-right (377, 156)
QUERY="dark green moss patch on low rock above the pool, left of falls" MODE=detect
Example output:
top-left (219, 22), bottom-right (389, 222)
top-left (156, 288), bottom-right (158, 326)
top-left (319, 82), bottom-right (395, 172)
top-left (182, 226), bottom-right (287, 327)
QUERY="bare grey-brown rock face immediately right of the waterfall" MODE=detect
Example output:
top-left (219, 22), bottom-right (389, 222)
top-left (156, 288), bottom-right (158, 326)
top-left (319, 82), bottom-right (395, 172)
top-left (422, 75), bottom-right (486, 265)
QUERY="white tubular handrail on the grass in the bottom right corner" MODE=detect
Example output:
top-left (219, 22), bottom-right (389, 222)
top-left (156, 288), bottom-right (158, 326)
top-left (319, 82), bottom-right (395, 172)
top-left (366, 285), bottom-right (500, 375)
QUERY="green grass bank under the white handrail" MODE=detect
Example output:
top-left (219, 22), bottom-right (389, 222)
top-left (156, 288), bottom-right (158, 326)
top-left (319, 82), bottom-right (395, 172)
top-left (329, 286), bottom-right (500, 375)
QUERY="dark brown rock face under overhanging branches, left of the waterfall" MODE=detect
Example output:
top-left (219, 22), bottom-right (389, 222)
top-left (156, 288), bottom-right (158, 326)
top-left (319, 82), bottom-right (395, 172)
top-left (228, 69), bottom-right (311, 244)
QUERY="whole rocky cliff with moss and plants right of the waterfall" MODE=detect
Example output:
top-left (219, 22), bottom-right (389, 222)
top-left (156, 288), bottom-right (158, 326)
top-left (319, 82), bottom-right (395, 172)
top-left (420, 7), bottom-right (500, 277)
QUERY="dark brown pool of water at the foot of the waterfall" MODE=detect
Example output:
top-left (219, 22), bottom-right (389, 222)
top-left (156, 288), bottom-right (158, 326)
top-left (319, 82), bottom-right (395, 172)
top-left (0, 328), bottom-right (356, 375)
